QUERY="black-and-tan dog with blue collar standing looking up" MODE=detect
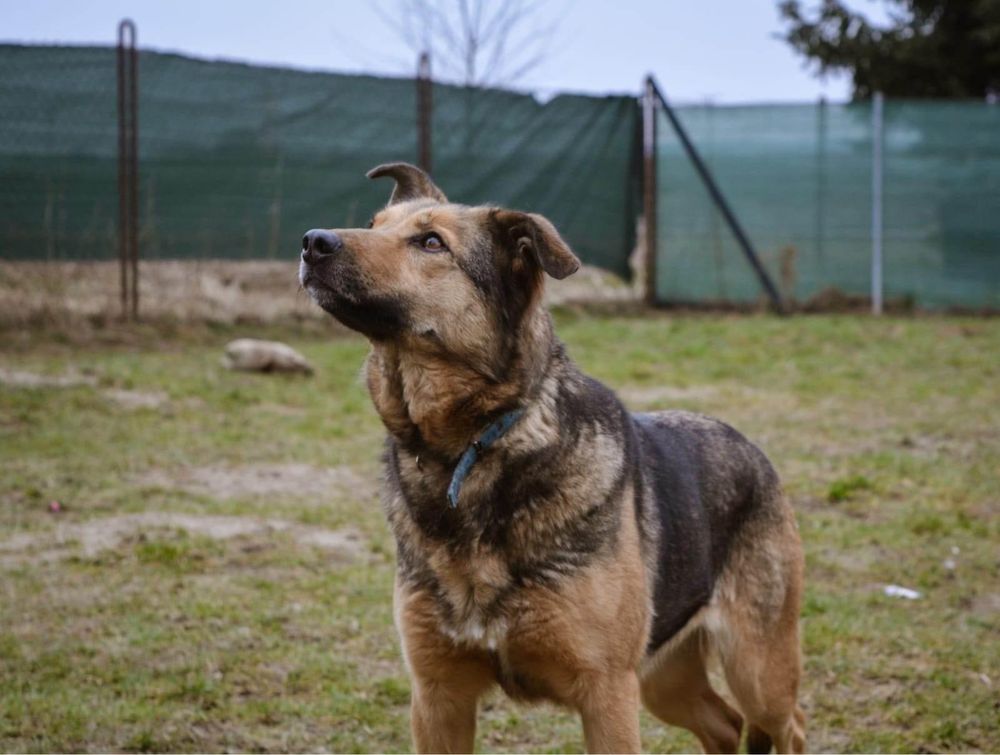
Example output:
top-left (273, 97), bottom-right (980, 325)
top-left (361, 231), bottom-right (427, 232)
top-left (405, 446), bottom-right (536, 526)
top-left (299, 163), bottom-right (805, 752)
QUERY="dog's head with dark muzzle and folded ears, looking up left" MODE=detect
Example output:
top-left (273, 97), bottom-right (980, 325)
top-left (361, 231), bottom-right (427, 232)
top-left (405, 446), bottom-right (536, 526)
top-left (299, 163), bottom-right (580, 372)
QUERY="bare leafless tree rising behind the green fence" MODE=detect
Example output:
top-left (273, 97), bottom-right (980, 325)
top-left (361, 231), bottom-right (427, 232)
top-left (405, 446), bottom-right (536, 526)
top-left (376, 0), bottom-right (555, 86)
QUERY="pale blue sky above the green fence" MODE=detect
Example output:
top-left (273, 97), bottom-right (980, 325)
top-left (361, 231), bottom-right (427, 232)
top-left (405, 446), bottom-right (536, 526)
top-left (0, 0), bottom-right (884, 104)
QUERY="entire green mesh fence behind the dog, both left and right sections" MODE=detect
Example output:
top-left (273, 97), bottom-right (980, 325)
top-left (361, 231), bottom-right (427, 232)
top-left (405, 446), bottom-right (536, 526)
top-left (0, 45), bottom-right (1000, 316)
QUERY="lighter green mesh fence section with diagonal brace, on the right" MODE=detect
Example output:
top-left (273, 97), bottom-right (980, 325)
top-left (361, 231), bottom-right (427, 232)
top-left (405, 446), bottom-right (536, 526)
top-left (656, 101), bottom-right (1000, 309)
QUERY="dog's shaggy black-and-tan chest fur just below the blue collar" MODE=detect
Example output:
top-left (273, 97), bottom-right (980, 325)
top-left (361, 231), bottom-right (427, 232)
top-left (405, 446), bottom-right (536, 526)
top-left (386, 366), bottom-right (631, 650)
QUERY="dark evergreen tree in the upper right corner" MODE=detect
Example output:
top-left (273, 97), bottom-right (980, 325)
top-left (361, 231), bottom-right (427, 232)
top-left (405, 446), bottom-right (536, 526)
top-left (778, 0), bottom-right (1000, 99)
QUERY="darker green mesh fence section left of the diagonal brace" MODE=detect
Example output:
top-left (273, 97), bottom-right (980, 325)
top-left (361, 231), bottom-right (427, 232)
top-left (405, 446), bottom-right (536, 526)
top-left (0, 45), bottom-right (638, 275)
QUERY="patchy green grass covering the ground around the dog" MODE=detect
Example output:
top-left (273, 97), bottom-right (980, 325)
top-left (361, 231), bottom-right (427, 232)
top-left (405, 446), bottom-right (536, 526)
top-left (0, 312), bottom-right (1000, 752)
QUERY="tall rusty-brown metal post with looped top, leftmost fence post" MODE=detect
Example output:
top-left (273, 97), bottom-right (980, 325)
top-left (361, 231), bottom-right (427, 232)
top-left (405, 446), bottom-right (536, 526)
top-left (117, 18), bottom-right (139, 320)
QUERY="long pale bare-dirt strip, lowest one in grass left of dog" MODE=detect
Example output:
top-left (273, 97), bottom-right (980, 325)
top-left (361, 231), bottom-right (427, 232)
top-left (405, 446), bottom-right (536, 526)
top-left (0, 511), bottom-right (365, 566)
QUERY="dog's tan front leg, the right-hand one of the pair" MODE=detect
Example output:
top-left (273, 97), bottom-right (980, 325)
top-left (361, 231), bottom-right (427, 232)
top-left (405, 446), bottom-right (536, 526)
top-left (579, 670), bottom-right (641, 753)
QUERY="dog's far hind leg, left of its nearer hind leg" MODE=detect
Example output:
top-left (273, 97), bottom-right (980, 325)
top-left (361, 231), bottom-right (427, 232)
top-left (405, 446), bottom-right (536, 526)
top-left (641, 629), bottom-right (743, 752)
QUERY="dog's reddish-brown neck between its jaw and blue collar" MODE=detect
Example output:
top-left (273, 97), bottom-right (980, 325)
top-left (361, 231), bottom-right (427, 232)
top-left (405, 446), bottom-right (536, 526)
top-left (366, 308), bottom-right (554, 460)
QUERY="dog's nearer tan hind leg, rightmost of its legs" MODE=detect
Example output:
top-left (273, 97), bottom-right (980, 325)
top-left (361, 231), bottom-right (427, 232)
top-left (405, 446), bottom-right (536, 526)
top-left (710, 512), bottom-right (805, 753)
